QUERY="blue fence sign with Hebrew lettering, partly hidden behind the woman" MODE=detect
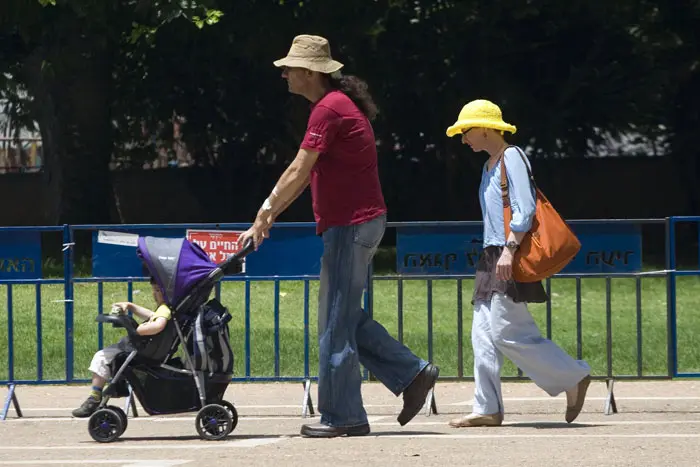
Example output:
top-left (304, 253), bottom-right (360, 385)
top-left (396, 222), bottom-right (642, 275)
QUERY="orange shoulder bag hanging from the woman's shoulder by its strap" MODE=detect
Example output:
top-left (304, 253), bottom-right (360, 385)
top-left (500, 146), bottom-right (581, 282)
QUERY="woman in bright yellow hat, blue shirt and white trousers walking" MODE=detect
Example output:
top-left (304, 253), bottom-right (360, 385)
top-left (447, 99), bottom-right (590, 427)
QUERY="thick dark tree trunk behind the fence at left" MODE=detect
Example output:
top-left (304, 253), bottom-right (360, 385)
top-left (25, 29), bottom-right (114, 224)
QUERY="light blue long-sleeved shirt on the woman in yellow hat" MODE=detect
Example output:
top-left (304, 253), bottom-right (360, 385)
top-left (479, 147), bottom-right (535, 248)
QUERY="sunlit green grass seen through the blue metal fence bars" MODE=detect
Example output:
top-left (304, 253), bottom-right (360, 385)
top-left (0, 277), bottom-right (700, 380)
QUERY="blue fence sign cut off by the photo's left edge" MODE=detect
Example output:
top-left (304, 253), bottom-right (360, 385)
top-left (0, 231), bottom-right (41, 279)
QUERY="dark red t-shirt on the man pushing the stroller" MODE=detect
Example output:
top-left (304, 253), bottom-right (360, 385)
top-left (301, 91), bottom-right (386, 234)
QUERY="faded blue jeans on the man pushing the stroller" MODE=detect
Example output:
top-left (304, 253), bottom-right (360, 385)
top-left (318, 215), bottom-right (428, 427)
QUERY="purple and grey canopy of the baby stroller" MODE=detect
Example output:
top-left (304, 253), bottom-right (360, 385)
top-left (136, 237), bottom-right (217, 306)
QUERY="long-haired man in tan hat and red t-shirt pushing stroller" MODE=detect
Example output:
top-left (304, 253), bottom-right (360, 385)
top-left (240, 35), bottom-right (439, 438)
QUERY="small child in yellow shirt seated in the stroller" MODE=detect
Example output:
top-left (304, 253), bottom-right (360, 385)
top-left (73, 276), bottom-right (172, 418)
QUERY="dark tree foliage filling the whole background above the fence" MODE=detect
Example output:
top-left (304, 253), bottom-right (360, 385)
top-left (0, 0), bottom-right (700, 221)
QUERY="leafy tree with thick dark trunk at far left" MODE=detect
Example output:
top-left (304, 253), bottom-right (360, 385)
top-left (0, 0), bottom-right (219, 223)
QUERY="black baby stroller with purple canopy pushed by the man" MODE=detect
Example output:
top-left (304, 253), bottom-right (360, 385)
top-left (88, 237), bottom-right (253, 443)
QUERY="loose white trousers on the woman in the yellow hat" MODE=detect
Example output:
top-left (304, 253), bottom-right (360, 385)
top-left (472, 294), bottom-right (591, 415)
